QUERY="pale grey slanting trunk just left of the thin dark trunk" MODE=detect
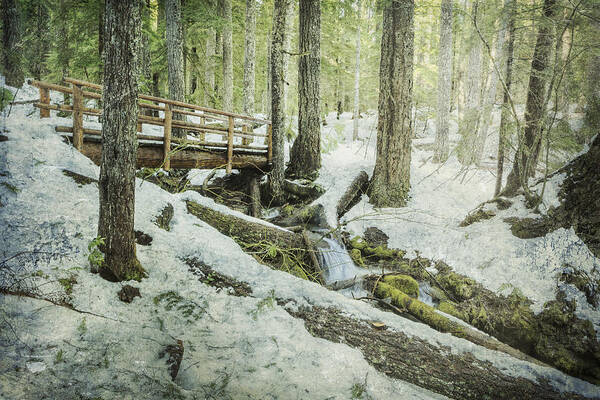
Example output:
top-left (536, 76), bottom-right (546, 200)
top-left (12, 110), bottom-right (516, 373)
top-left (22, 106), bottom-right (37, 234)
top-left (475, 0), bottom-right (512, 164)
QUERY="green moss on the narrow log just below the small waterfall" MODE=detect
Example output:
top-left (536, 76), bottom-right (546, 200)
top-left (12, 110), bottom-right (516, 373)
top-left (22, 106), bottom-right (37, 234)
top-left (375, 282), bottom-right (464, 337)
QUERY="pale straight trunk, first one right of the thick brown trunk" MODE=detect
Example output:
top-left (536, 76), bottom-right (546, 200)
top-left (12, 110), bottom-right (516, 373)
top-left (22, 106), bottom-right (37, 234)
top-left (433, 0), bottom-right (452, 163)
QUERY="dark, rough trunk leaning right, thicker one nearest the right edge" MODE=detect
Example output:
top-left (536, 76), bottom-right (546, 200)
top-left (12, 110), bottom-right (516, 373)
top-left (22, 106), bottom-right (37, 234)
top-left (502, 0), bottom-right (557, 196)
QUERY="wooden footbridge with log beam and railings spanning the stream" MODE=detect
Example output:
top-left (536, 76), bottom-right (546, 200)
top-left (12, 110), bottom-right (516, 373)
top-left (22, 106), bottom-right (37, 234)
top-left (29, 78), bottom-right (273, 173)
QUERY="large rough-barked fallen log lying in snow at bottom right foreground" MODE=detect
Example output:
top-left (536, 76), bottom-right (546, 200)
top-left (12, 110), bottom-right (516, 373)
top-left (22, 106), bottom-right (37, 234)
top-left (288, 307), bottom-right (583, 400)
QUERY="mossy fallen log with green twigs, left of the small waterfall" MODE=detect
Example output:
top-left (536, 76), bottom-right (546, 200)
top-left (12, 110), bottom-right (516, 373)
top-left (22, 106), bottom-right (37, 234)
top-left (187, 201), bottom-right (321, 282)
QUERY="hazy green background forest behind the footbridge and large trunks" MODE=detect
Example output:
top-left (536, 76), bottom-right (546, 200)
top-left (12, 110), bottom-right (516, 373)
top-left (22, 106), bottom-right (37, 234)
top-left (3, 0), bottom-right (599, 174)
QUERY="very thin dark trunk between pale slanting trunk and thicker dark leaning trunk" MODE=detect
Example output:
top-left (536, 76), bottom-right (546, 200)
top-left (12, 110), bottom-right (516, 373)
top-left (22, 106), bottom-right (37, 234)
top-left (494, 0), bottom-right (516, 196)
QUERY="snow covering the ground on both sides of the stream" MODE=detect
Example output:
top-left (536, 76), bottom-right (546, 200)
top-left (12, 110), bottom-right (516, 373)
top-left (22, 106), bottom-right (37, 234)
top-left (0, 82), bottom-right (600, 399)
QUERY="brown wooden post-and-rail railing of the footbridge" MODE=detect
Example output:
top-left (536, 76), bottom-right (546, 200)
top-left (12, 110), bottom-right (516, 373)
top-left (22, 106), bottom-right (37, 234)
top-left (29, 78), bottom-right (273, 173)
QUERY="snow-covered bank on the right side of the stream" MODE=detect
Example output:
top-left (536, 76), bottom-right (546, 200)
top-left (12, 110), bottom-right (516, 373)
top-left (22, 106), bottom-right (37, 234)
top-left (315, 113), bottom-right (600, 332)
